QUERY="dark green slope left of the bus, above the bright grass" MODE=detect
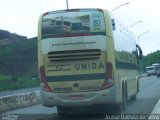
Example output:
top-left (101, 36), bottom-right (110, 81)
top-left (0, 38), bottom-right (37, 77)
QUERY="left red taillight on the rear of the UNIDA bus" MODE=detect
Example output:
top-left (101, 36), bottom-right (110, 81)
top-left (39, 66), bottom-right (52, 92)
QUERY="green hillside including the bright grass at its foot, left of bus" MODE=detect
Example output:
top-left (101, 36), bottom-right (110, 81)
top-left (0, 38), bottom-right (39, 91)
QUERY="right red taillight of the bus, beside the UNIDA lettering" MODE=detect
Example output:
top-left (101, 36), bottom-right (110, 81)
top-left (101, 62), bottom-right (114, 90)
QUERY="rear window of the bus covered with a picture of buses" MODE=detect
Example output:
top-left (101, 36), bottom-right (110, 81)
top-left (42, 10), bottom-right (105, 38)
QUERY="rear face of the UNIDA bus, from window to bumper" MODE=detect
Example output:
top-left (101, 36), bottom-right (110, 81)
top-left (39, 9), bottom-right (114, 106)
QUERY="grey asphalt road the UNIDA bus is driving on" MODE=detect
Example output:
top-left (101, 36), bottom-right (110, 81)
top-left (2, 76), bottom-right (160, 120)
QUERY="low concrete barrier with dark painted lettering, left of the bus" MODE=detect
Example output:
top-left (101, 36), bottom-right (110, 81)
top-left (0, 91), bottom-right (41, 112)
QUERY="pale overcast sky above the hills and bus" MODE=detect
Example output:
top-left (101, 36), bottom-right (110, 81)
top-left (0, 0), bottom-right (160, 55)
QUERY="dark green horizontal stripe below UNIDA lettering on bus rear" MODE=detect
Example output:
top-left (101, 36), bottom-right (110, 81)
top-left (46, 73), bottom-right (106, 82)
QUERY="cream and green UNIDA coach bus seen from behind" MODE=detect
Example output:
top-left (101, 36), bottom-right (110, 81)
top-left (38, 8), bottom-right (142, 115)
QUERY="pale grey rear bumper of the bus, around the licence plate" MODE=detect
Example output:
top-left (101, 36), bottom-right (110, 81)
top-left (41, 86), bottom-right (116, 107)
